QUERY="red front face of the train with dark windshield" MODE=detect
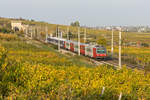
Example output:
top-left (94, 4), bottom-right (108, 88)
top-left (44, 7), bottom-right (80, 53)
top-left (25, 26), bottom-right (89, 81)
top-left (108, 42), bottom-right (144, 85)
top-left (96, 46), bottom-right (107, 59)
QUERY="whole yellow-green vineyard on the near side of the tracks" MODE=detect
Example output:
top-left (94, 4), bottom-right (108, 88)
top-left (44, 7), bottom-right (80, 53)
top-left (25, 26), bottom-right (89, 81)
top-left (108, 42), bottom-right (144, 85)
top-left (0, 34), bottom-right (150, 100)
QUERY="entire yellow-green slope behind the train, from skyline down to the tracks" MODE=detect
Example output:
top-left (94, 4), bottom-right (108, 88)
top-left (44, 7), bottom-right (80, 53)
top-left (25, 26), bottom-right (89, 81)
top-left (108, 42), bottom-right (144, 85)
top-left (0, 18), bottom-right (150, 69)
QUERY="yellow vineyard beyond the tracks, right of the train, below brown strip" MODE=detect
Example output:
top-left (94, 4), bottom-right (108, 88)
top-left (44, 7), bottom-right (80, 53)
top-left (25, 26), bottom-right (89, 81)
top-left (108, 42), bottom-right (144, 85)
top-left (108, 46), bottom-right (150, 71)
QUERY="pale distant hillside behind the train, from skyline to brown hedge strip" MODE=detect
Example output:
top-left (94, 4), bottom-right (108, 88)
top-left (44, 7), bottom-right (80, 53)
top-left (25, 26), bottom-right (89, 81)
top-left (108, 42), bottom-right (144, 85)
top-left (0, 18), bottom-right (150, 45)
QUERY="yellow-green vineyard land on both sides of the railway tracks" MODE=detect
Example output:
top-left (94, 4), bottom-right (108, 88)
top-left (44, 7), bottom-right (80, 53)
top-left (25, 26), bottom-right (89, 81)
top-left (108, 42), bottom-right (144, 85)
top-left (0, 18), bottom-right (150, 100)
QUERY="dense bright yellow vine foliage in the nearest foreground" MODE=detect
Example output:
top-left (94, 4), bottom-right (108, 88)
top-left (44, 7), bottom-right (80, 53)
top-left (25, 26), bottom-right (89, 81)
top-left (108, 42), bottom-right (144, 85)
top-left (1, 47), bottom-right (150, 100)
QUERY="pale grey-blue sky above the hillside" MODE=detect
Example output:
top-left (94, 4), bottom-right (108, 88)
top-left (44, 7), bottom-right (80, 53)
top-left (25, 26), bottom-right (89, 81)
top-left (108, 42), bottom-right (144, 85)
top-left (0, 0), bottom-right (150, 26)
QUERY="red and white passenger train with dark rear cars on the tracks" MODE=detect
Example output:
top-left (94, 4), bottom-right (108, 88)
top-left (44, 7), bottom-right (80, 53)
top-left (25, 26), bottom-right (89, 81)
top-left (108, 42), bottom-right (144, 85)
top-left (47, 37), bottom-right (107, 59)
